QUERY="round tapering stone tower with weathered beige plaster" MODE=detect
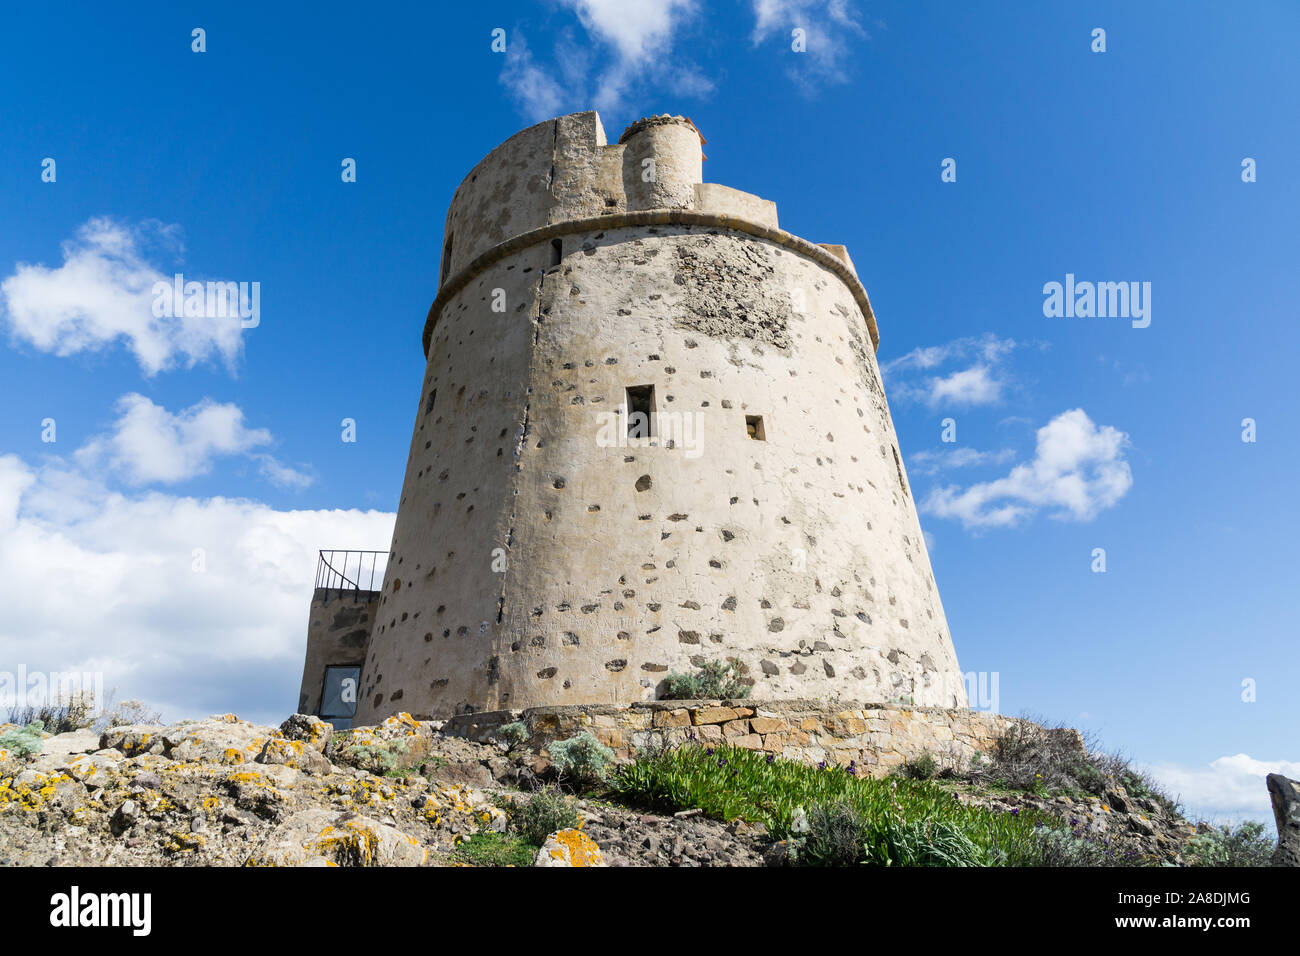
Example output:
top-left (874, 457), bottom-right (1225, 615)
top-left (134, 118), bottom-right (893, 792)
top-left (356, 112), bottom-right (966, 723)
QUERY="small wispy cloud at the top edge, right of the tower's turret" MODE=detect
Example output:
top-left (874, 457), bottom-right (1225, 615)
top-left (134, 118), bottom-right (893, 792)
top-left (751, 0), bottom-right (867, 96)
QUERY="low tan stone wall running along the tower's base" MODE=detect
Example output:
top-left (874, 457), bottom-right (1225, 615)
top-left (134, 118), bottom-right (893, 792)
top-left (442, 700), bottom-right (1040, 777)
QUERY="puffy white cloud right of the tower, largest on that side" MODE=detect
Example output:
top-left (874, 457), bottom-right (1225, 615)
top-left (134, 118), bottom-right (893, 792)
top-left (922, 408), bottom-right (1132, 528)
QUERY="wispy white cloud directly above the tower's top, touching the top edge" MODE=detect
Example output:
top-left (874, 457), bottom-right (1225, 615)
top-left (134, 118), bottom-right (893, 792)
top-left (501, 0), bottom-right (714, 120)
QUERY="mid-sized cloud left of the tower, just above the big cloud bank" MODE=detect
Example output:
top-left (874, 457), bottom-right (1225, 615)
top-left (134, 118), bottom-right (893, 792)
top-left (75, 393), bottom-right (312, 488)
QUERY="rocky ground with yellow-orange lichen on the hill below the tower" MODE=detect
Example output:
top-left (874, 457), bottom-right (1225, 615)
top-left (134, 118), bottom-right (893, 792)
top-left (0, 714), bottom-right (1248, 866)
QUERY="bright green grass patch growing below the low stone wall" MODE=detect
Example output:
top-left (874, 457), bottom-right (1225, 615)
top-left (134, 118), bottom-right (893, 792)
top-left (608, 745), bottom-right (1061, 866)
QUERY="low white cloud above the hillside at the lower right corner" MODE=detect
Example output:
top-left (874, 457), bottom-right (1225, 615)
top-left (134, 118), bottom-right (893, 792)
top-left (1143, 753), bottom-right (1300, 834)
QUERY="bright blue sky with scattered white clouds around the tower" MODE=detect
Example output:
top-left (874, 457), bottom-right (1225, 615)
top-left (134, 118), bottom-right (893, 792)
top-left (0, 0), bottom-right (1300, 816)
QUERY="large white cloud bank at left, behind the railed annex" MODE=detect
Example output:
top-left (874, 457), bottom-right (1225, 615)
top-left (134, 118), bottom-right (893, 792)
top-left (0, 455), bottom-right (394, 721)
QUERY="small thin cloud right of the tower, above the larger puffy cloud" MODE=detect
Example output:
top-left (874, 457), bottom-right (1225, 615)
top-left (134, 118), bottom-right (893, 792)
top-left (880, 333), bottom-right (1018, 408)
